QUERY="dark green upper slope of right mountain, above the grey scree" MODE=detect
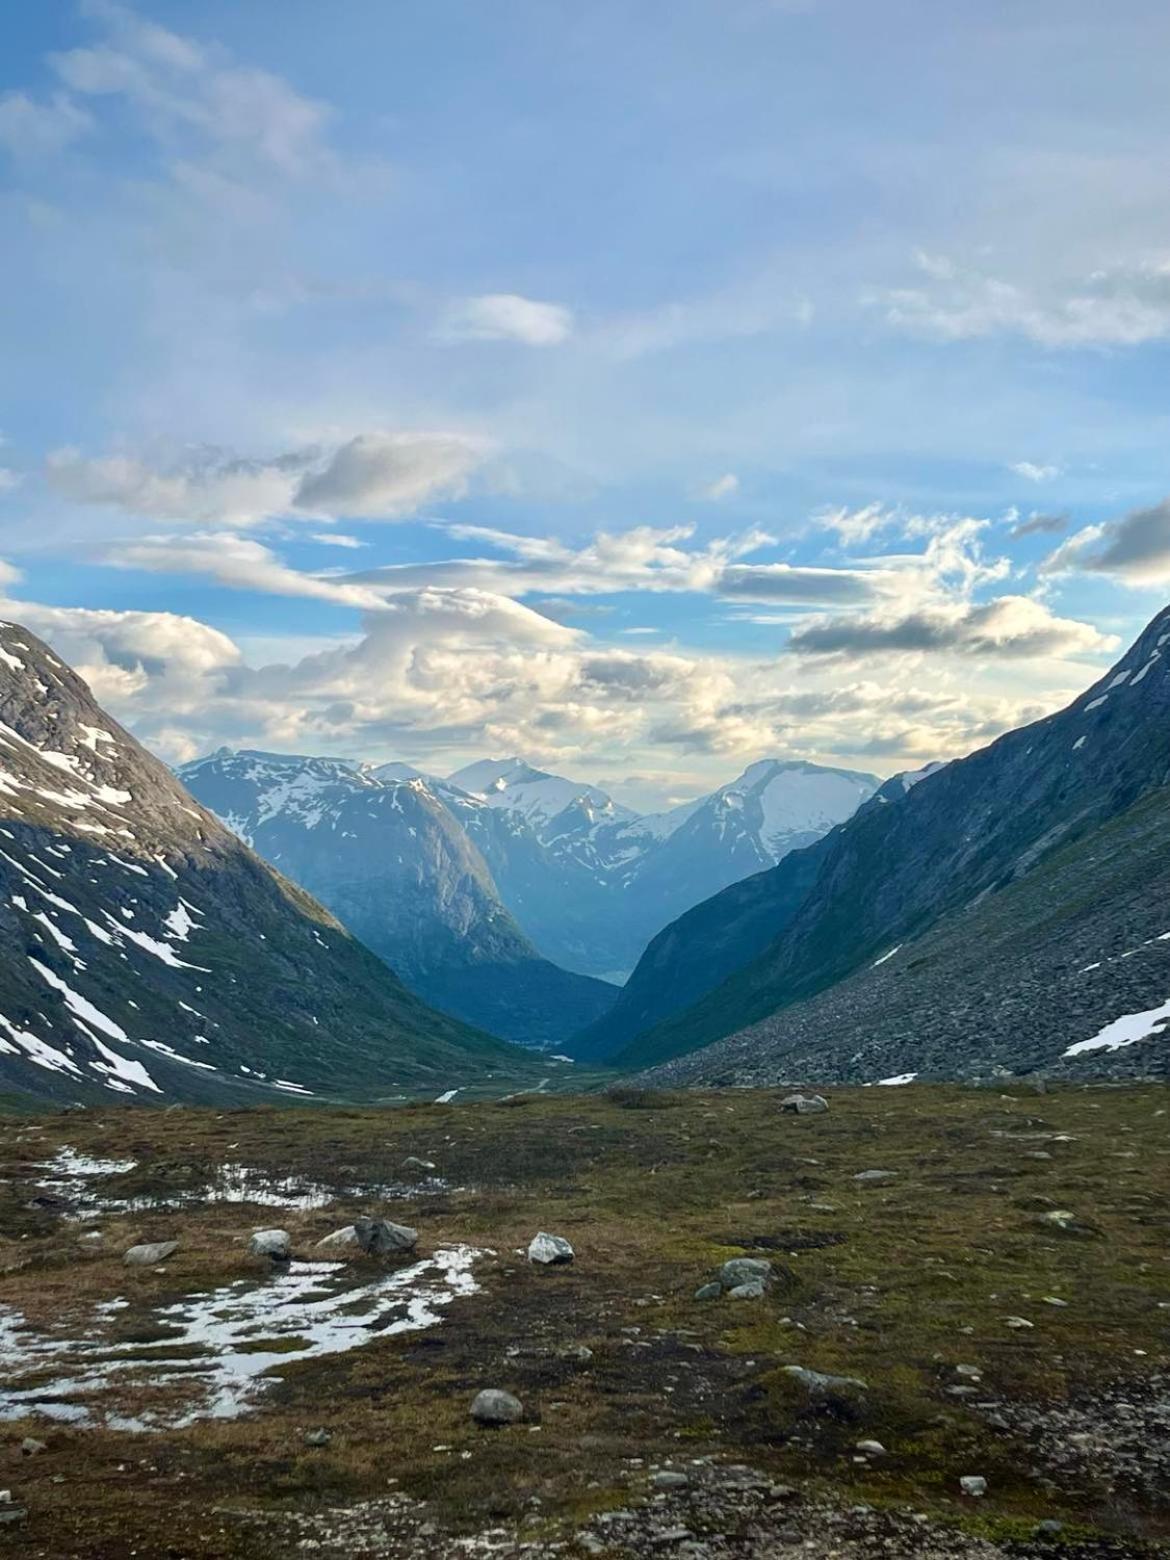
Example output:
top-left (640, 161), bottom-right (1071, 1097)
top-left (618, 612), bottom-right (1170, 1065)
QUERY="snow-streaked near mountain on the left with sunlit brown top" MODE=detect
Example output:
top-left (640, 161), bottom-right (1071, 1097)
top-left (0, 624), bottom-right (532, 1103)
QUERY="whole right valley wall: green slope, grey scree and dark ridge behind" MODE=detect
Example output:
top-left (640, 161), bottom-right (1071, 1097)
top-left (605, 610), bottom-right (1170, 1083)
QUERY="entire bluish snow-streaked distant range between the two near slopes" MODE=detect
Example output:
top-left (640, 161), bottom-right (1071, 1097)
top-left (179, 749), bottom-right (877, 1048)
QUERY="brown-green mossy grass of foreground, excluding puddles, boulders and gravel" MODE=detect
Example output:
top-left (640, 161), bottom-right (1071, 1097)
top-left (0, 1086), bottom-right (1170, 1557)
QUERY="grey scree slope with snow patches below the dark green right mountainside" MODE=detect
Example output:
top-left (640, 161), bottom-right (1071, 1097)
top-left (654, 789), bottom-right (1170, 1086)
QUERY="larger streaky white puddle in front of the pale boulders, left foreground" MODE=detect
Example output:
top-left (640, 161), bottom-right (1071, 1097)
top-left (0, 1245), bottom-right (485, 1431)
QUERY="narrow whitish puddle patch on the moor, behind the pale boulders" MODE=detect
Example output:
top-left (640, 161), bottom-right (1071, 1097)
top-left (36, 1148), bottom-right (451, 1218)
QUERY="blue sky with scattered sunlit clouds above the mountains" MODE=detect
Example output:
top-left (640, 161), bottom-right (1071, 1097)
top-left (0, 0), bottom-right (1170, 810)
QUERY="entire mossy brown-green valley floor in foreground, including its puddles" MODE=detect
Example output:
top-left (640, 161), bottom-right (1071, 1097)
top-left (0, 1084), bottom-right (1170, 1560)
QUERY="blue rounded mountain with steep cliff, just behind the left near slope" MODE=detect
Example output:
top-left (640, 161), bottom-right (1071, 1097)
top-left (179, 749), bottom-right (616, 1047)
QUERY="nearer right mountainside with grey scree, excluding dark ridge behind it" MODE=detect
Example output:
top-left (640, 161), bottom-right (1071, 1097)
top-left (616, 610), bottom-right (1170, 1078)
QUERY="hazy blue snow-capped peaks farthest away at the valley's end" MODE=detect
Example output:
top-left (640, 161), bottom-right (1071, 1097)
top-left (440, 758), bottom-right (878, 978)
